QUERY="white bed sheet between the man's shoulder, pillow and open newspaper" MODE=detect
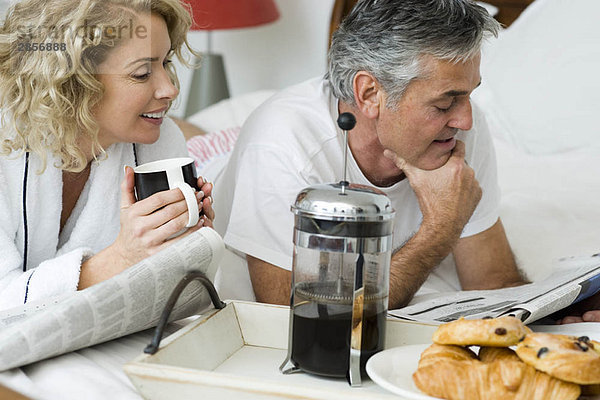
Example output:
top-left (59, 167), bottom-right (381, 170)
top-left (495, 140), bottom-right (600, 280)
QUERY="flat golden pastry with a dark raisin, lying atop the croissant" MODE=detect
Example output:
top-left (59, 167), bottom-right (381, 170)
top-left (433, 316), bottom-right (531, 347)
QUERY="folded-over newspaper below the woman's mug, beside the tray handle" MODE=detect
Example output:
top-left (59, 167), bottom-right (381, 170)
top-left (0, 228), bottom-right (224, 371)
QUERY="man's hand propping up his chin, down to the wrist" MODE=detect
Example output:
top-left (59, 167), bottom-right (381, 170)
top-left (383, 140), bottom-right (481, 239)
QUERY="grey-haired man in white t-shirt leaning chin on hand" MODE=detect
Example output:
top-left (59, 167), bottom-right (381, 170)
top-left (215, 0), bottom-right (596, 318)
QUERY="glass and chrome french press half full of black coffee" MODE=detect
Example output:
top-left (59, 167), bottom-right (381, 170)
top-left (280, 113), bottom-right (394, 386)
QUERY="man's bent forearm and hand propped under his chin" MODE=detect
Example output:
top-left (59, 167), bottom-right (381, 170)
top-left (383, 141), bottom-right (488, 308)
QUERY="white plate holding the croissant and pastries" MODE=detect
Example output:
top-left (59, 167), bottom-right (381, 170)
top-left (367, 344), bottom-right (437, 400)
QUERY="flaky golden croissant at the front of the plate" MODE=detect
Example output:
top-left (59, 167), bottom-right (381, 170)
top-left (413, 344), bottom-right (581, 400)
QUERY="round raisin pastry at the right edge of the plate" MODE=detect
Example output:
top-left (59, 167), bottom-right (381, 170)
top-left (516, 333), bottom-right (600, 385)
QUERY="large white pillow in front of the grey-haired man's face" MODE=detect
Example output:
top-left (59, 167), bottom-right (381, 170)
top-left (473, 0), bottom-right (600, 154)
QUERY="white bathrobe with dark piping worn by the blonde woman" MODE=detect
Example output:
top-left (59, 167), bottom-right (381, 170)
top-left (0, 118), bottom-right (187, 310)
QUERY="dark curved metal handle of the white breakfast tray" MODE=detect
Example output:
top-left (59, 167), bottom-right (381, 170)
top-left (144, 271), bottom-right (227, 354)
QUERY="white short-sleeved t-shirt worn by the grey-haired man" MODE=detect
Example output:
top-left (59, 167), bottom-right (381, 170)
top-left (215, 78), bottom-right (500, 294)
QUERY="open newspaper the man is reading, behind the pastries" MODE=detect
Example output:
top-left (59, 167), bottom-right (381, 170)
top-left (389, 254), bottom-right (600, 324)
